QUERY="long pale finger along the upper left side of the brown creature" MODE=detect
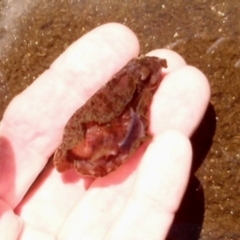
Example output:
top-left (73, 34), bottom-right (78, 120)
top-left (0, 24), bottom-right (139, 209)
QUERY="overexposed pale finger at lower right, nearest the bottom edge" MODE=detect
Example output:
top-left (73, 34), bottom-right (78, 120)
top-left (105, 131), bottom-right (191, 240)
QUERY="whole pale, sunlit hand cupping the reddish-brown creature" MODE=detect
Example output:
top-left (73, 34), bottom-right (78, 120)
top-left (0, 23), bottom-right (210, 240)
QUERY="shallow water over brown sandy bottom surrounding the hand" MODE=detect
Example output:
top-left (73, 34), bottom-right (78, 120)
top-left (0, 0), bottom-right (240, 240)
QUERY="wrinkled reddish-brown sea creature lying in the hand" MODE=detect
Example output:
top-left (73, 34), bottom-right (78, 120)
top-left (53, 56), bottom-right (167, 177)
